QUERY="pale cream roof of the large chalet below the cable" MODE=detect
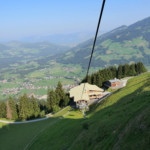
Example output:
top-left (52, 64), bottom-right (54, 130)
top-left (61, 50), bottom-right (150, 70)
top-left (69, 83), bottom-right (104, 101)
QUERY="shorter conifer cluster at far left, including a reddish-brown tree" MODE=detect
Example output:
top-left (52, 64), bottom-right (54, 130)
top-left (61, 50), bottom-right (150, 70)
top-left (0, 94), bottom-right (45, 120)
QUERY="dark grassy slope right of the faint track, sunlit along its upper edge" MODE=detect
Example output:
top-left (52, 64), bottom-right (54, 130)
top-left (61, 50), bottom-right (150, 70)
top-left (31, 74), bottom-right (150, 150)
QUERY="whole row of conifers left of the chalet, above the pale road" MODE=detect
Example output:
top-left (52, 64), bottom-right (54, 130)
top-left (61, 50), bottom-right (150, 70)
top-left (0, 82), bottom-right (69, 120)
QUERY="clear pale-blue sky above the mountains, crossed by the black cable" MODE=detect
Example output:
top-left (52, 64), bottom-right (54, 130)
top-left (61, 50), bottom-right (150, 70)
top-left (0, 0), bottom-right (150, 40)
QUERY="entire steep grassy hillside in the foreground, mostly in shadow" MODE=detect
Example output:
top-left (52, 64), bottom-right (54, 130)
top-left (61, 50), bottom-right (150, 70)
top-left (0, 73), bottom-right (150, 150)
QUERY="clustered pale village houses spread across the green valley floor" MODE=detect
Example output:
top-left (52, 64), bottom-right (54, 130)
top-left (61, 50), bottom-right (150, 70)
top-left (0, 76), bottom-right (79, 100)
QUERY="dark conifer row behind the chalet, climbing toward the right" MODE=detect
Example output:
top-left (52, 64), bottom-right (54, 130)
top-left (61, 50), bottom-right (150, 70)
top-left (81, 62), bottom-right (147, 87)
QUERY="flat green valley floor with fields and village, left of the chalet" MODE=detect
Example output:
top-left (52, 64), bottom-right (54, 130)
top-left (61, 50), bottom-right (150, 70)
top-left (0, 63), bottom-right (85, 100)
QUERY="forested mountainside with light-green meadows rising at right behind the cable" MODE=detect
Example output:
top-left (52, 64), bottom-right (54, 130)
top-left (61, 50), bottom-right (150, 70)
top-left (57, 17), bottom-right (150, 67)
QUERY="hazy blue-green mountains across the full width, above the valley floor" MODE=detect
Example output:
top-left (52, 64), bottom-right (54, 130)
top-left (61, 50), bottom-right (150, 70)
top-left (0, 17), bottom-right (150, 71)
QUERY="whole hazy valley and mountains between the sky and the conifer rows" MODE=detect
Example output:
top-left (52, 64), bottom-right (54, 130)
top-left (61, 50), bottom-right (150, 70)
top-left (0, 18), bottom-right (150, 99)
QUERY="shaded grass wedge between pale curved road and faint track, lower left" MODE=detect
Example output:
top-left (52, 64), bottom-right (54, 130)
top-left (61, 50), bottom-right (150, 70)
top-left (0, 107), bottom-right (70, 150)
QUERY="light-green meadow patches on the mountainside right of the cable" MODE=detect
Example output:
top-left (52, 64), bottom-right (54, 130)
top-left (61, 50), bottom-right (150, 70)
top-left (94, 36), bottom-right (150, 64)
